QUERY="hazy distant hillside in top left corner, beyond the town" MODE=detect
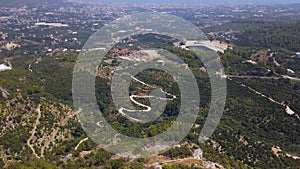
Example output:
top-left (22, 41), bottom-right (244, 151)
top-left (0, 0), bottom-right (63, 7)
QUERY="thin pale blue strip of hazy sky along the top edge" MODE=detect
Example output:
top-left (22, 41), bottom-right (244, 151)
top-left (84, 0), bottom-right (300, 4)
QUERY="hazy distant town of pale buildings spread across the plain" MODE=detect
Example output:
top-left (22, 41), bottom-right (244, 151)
top-left (0, 2), bottom-right (300, 56)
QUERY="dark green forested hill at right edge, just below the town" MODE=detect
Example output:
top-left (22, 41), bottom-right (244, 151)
top-left (235, 23), bottom-right (300, 51)
